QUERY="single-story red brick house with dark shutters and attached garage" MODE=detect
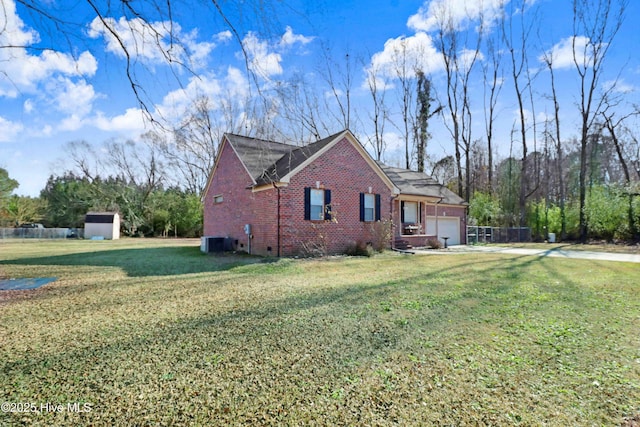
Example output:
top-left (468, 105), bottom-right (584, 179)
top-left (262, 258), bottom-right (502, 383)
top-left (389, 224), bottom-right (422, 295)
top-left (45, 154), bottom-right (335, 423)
top-left (203, 130), bottom-right (466, 256)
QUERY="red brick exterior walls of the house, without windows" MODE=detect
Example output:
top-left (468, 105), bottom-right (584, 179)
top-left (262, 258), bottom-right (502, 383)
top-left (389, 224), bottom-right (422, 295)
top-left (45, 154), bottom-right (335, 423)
top-left (204, 138), bottom-right (466, 256)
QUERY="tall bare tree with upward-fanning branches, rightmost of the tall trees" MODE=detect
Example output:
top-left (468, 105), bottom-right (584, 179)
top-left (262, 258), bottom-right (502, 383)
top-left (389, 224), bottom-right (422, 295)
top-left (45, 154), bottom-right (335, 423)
top-left (572, 0), bottom-right (629, 241)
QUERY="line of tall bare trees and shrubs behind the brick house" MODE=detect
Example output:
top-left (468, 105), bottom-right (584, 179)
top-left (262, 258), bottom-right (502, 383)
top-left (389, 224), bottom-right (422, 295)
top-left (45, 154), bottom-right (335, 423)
top-left (5, 0), bottom-right (640, 240)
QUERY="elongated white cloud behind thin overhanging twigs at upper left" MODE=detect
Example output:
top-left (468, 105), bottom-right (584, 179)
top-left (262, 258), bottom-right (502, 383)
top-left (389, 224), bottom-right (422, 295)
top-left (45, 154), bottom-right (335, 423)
top-left (87, 17), bottom-right (215, 68)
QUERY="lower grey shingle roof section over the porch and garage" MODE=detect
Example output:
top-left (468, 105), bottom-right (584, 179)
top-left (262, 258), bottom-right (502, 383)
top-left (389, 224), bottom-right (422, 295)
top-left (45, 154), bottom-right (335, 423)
top-left (378, 162), bottom-right (467, 205)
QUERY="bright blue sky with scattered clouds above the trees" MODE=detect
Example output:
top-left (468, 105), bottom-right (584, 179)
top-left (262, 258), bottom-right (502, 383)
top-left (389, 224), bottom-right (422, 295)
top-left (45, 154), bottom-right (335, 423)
top-left (0, 0), bottom-right (640, 196)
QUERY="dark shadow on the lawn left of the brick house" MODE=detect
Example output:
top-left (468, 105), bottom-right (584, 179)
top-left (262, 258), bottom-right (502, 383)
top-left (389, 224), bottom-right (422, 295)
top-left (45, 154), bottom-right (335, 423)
top-left (0, 246), bottom-right (277, 277)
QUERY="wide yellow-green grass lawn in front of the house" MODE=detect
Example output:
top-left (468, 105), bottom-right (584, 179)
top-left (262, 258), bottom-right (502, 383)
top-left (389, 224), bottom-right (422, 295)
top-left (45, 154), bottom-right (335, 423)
top-left (0, 240), bottom-right (640, 426)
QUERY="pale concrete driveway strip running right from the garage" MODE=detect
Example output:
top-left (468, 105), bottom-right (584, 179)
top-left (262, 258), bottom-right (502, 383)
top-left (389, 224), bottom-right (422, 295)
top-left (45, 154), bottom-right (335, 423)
top-left (414, 245), bottom-right (640, 263)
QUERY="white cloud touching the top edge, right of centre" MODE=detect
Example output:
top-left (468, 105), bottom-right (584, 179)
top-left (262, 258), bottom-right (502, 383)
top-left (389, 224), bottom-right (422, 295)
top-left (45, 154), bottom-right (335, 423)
top-left (407, 0), bottom-right (510, 31)
